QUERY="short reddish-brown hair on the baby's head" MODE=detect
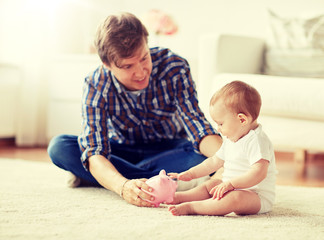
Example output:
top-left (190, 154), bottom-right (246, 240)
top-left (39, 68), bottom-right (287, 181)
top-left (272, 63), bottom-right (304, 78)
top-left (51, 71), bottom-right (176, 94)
top-left (210, 81), bottom-right (261, 121)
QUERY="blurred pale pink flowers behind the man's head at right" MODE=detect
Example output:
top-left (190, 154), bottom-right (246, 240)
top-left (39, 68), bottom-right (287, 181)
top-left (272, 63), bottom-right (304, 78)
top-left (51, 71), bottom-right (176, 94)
top-left (143, 9), bottom-right (178, 35)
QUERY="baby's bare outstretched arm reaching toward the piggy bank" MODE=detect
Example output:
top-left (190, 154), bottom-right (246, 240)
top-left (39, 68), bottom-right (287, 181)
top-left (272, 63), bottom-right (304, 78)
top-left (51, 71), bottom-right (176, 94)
top-left (168, 156), bottom-right (224, 181)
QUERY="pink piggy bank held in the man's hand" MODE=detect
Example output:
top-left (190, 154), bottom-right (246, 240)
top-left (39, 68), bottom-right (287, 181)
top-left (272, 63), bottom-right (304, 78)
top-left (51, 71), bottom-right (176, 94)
top-left (143, 170), bottom-right (178, 207)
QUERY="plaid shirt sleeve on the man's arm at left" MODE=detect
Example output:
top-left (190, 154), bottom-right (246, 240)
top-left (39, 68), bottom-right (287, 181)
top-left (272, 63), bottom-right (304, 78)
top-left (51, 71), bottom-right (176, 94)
top-left (78, 71), bottom-right (110, 170)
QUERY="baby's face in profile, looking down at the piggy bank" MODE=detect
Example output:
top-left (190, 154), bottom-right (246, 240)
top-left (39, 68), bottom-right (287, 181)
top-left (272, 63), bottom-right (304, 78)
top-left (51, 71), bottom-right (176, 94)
top-left (209, 100), bottom-right (242, 142)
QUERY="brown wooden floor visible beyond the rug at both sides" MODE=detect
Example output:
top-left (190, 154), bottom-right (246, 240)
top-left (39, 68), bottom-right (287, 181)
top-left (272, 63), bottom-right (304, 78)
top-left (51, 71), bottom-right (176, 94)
top-left (0, 141), bottom-right (324, 187)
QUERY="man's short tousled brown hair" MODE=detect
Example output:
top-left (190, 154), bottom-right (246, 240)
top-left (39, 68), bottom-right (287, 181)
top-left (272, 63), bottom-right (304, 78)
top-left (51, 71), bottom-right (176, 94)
top-left (95, 13), bottom-right (148, 66)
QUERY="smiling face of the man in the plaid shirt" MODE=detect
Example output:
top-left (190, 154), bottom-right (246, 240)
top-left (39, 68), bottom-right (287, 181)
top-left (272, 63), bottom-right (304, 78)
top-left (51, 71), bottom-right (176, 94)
top-left (105, 41), bottom-right (152, 91)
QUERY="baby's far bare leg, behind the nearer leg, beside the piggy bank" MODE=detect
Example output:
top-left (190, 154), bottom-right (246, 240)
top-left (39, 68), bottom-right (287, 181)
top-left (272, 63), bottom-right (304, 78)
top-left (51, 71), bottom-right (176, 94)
top-left (171, 179), bottom-right (221, 204)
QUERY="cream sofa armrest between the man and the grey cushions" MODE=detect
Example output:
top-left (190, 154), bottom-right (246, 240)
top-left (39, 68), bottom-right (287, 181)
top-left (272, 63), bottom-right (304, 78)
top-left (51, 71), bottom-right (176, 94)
top-left (197, 34), bottom-right (265, 113)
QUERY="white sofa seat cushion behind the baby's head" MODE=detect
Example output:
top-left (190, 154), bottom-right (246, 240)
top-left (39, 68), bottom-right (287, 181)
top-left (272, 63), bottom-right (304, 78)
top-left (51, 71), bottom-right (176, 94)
top-left (209, 73), bottom-right (324, 121)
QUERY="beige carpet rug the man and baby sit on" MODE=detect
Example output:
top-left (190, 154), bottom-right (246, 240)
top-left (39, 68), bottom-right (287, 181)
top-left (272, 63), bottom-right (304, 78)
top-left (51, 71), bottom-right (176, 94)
top-left (0, 159), bottom-right (324, 240)
